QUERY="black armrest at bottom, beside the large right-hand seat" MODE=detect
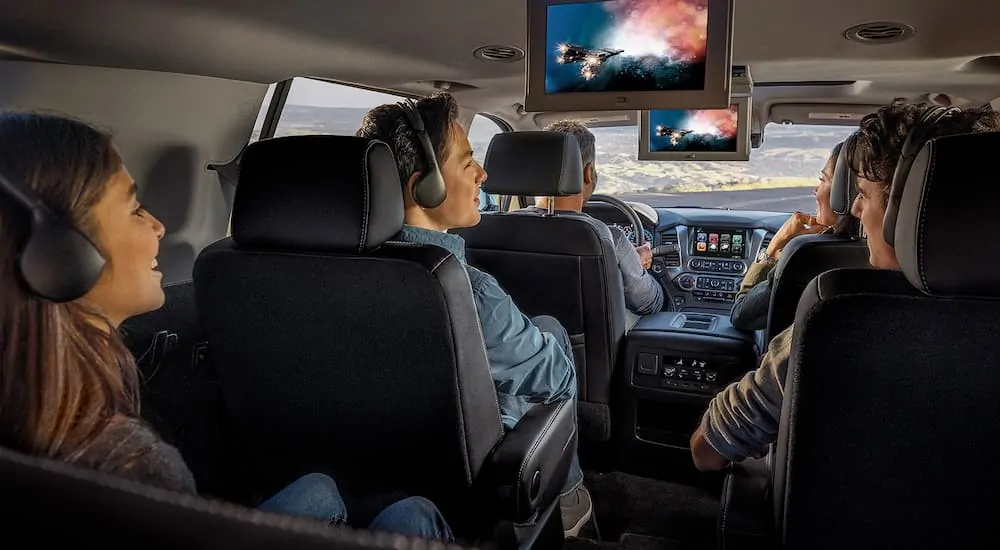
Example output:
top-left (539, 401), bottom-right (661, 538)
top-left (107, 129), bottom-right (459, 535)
top-left (719, 457), bottom-right (774, 550)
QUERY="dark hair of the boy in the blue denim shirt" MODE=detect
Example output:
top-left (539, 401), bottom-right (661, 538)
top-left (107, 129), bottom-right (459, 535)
top-left (354, 92), bottom-right (458, 189)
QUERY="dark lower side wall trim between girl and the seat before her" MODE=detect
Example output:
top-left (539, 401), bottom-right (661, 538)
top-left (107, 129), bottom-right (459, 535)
top-left (119, 281), bottom-right (225, 495)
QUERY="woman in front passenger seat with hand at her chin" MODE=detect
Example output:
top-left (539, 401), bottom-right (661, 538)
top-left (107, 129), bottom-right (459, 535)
top-left (729, 141), bottom-right (856, 332)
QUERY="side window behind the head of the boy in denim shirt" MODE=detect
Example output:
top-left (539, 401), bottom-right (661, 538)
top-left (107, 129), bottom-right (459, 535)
top-left (251, 77), bottom-right (402, 141)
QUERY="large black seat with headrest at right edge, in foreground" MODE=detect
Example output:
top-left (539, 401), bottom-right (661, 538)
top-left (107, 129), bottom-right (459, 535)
top-left (774, 133), bottom-right (1000, 549)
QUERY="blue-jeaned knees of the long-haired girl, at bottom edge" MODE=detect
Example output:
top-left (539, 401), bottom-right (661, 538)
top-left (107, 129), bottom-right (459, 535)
top-left (257, 474), bottom-right (454, 542)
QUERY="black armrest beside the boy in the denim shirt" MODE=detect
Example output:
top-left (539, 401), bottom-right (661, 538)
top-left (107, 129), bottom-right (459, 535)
top-left (477, 400), bottom-right (576, 523)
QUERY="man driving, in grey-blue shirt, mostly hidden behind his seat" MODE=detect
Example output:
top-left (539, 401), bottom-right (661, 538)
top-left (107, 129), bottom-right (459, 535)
top-left (521, 120), bottom-right (663, 315)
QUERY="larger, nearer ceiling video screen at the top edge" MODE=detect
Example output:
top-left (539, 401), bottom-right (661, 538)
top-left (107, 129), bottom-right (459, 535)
top-left (524, 0), bottom-right (733, 112)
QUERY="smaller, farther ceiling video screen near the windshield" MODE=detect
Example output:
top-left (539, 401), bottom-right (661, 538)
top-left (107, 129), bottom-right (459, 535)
top-left (638, 97), bottom-right (751, 161)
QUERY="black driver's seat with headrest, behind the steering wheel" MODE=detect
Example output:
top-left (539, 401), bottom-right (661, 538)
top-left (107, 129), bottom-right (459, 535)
top-left (455, 131), bottom-right (625, 441)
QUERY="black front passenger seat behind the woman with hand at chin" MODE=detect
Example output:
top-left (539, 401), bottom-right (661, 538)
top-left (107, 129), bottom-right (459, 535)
top-left (764, 136), bottom-right (869, 343)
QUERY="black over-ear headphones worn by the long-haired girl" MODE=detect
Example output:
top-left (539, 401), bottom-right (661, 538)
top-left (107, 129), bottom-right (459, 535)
top-left (0, 175), bottom-right (104, 302)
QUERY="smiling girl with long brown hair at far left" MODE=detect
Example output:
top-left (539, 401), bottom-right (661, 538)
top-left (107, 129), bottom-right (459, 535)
top-left (0, 113), bottom-right (452, 542)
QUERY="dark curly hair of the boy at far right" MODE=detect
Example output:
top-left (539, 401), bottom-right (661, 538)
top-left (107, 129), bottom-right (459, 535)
top-left (844, 103), bottom-right (1000, 198)
